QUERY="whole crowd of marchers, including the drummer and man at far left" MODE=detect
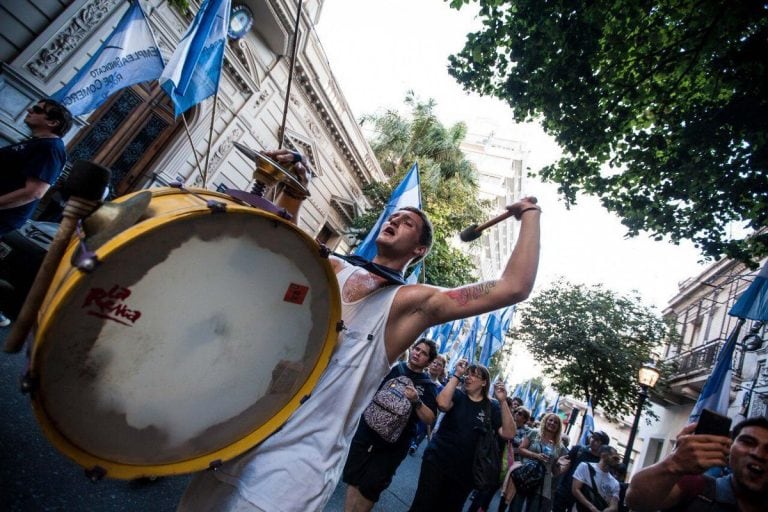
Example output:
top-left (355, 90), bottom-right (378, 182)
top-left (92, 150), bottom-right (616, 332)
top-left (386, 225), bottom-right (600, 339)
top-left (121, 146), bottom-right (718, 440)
top-left (6, 105), bottom-right (768, 512)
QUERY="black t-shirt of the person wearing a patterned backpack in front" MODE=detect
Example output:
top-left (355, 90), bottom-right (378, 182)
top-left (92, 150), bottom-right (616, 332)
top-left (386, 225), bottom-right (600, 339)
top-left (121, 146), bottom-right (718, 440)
top-left (354, 362), bottom-right (437, 451)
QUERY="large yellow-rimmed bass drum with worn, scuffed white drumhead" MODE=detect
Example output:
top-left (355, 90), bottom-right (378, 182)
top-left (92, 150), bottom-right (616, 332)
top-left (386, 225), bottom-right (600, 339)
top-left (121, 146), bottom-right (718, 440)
top-left (29, 189), bottom-right (341, 479)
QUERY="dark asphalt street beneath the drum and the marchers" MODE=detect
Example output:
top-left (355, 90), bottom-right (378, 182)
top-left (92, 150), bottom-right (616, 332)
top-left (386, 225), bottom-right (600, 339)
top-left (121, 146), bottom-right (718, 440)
top-left (0, 328), bottom-right (496, 512)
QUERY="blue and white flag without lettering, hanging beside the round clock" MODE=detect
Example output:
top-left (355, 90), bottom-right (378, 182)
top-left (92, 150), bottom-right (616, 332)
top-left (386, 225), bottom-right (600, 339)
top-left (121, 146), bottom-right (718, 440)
top-left (160, 0), bottom-right (231, 116)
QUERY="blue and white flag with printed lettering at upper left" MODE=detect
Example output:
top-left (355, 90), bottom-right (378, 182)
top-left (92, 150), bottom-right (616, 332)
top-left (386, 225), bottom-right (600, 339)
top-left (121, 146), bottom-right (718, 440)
top-left (51, 1), bottom-right (163, 116)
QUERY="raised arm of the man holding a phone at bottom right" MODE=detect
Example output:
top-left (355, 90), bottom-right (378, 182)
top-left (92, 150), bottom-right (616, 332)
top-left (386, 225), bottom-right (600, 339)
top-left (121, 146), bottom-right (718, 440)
top-left (626, 424), bottom-right (731, 512)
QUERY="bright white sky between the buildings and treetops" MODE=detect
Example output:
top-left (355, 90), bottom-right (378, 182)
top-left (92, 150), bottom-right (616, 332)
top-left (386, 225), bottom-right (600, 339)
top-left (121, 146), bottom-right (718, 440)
top-left (317, 0), bottom-right (701, 309)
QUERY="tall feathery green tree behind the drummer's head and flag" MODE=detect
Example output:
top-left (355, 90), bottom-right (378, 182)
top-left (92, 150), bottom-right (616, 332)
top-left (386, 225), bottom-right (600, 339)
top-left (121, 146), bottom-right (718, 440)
top-left (352, 92), bottom-right (484, 287)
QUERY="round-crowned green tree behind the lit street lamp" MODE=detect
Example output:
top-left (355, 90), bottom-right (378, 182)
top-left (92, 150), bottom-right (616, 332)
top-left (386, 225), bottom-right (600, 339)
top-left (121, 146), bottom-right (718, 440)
top-left (504, 279), bottom-right (666, 418)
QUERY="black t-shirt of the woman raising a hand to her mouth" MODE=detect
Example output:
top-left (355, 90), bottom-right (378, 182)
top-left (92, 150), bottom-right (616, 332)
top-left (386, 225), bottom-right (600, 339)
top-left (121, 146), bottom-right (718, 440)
top-left (424, 389), bottom-right (501, 482)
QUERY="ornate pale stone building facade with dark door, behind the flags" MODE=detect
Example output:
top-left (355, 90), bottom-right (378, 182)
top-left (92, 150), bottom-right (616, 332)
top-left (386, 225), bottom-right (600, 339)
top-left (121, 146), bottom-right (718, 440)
top-left (0, 0), bottom-right (383, 251)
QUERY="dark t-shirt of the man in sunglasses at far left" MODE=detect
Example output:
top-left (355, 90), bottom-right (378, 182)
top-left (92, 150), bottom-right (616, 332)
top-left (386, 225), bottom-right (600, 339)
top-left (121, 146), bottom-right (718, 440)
top-left (0, 137), bottom-right (67, 232)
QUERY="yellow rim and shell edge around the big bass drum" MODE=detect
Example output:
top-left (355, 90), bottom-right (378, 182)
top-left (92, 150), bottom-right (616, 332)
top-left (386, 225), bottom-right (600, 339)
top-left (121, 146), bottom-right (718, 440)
top-left (30, 189), bottom-right (341, 480)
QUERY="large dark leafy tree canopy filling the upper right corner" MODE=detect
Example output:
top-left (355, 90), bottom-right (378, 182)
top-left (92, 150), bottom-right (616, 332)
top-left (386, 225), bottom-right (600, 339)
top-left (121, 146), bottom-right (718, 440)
top-left (448, 0), bottom-right (768, 266)
